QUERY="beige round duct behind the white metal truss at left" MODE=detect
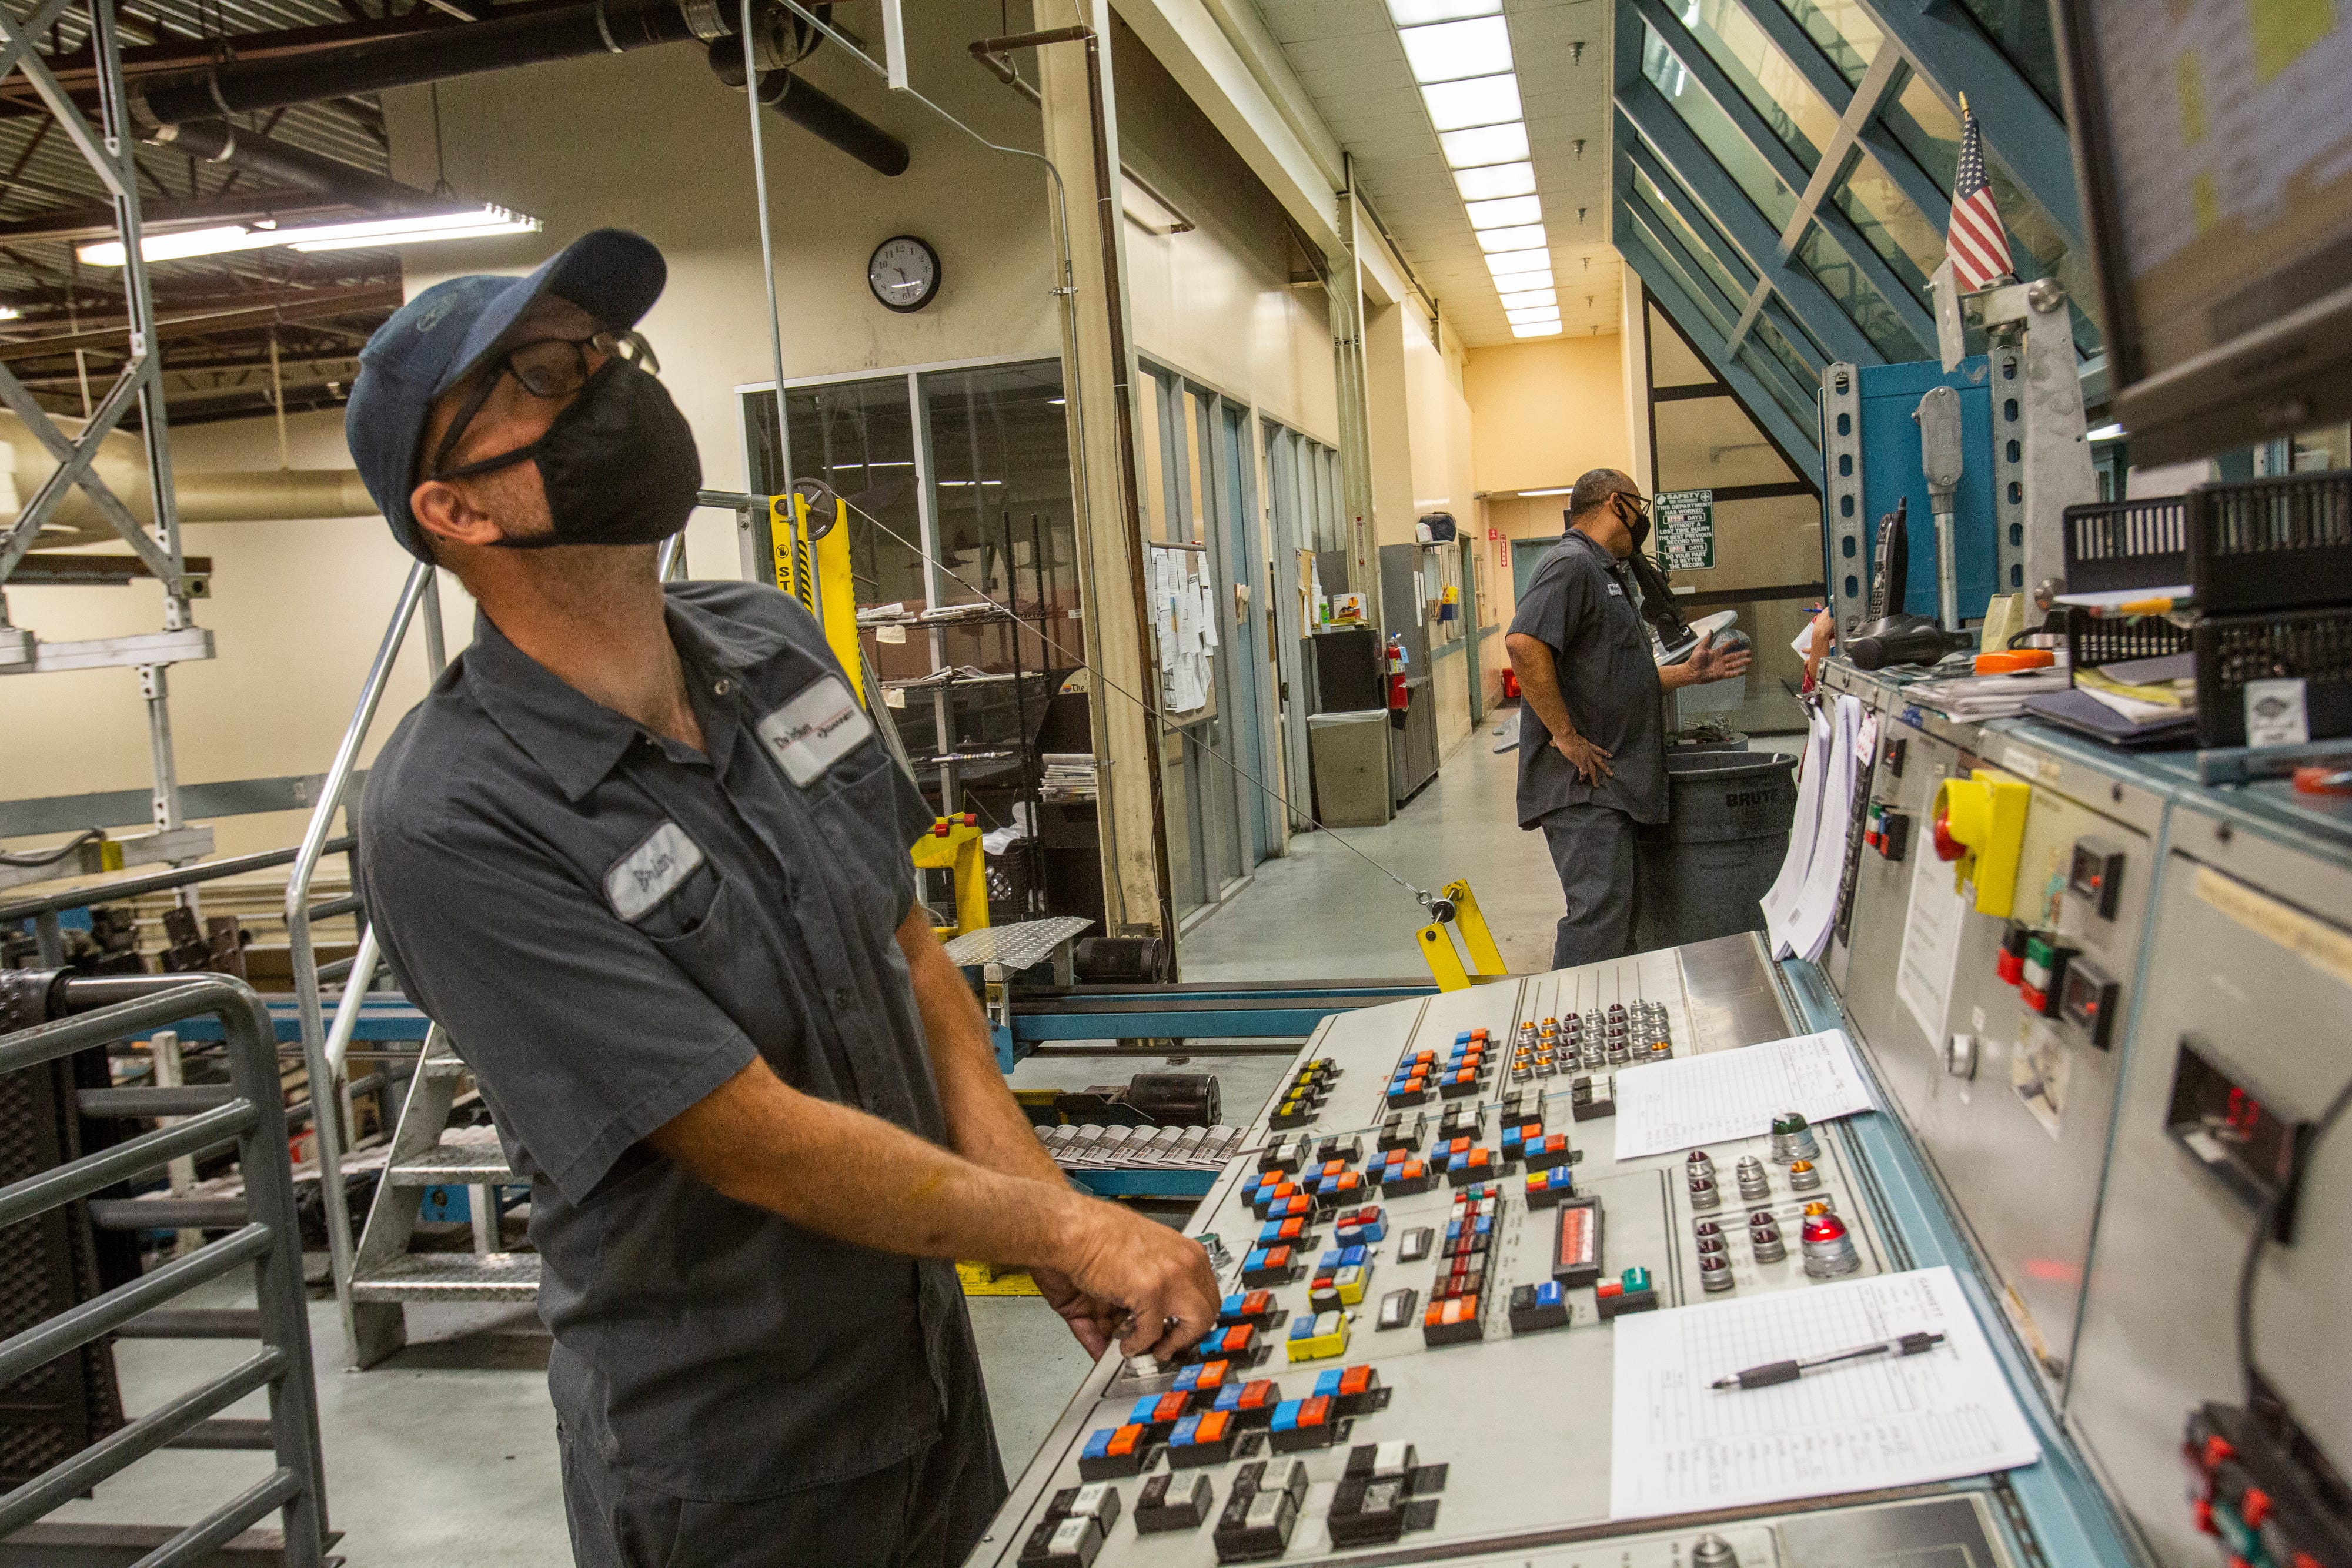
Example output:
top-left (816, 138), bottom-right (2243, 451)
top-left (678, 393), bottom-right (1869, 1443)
top-left (0, 414), bottom-right (376, 550)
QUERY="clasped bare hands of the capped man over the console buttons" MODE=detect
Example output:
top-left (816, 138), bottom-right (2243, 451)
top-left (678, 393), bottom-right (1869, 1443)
top-left (1054, 1199), bottom-right (1218, 1361)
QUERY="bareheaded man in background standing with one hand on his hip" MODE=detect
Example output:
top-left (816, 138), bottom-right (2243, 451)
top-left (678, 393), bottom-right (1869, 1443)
top-left (1503, 468), bottom-right (1748, 968)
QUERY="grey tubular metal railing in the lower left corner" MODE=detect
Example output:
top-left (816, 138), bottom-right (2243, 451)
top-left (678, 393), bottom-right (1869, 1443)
top-left (0, 975), bottom-right (327, 1568)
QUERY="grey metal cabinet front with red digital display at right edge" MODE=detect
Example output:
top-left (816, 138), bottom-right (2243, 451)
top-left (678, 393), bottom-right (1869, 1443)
top-left (2065, 804), bottom-right (2352, 1568)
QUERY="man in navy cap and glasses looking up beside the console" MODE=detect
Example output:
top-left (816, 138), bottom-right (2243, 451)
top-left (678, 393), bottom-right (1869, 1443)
top-left (346, 230), bottom-right (1216, 1568)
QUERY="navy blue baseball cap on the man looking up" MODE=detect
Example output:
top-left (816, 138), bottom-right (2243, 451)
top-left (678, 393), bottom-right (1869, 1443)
top-left (343, 228), bottom-right (670, 562)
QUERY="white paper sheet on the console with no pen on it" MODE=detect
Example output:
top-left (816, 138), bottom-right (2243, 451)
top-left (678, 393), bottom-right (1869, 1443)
top-left (1616, 1029), bottom-right (1872, 1159)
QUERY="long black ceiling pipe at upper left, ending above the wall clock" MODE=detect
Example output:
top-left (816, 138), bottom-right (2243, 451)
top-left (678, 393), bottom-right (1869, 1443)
top-left (132, 0), bottom-right (908, 174)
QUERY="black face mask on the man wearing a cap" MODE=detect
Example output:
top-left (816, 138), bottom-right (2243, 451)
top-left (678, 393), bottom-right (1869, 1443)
top-left (442, 360), bottom-right (703, 550)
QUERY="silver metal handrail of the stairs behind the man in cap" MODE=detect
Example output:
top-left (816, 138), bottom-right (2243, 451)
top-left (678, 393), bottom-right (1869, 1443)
top-left (285, 562), bottom-right (445, 1361)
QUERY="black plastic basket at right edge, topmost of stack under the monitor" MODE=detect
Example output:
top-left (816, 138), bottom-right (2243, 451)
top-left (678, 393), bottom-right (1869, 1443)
top-left (2183, 468), bottom-right (2352, 616)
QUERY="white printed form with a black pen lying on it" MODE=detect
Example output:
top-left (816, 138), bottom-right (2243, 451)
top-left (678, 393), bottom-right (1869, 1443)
top-left (1609, 1267), bottom-right (2042, 1519)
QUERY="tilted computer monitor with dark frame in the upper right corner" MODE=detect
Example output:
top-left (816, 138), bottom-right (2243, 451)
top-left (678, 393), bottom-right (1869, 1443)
top-left (2058, 0), bottom-right (2352, 463)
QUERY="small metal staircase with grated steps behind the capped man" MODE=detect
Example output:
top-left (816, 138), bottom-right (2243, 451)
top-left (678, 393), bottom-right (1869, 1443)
top-left (350, 1025), bottom-right (539, 1366)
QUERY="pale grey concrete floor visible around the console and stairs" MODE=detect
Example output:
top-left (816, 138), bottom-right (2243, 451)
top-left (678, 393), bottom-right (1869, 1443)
top-left (59, 710), bottom-right (1559, 1568)
